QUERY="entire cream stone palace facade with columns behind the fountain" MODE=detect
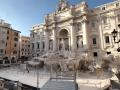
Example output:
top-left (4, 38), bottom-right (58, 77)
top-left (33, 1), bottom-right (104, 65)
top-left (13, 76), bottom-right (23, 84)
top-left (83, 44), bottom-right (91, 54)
top-left (30, 0), bottom-right (120, 59)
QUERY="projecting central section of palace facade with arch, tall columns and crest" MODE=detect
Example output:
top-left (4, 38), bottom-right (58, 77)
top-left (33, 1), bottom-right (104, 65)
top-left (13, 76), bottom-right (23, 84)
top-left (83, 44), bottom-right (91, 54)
top-left (45, 0), bottom-right (88, 51)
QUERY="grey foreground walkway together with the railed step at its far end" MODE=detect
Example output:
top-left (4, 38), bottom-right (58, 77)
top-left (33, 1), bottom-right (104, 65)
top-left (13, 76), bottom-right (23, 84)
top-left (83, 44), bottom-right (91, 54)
top-left (40, 71), bottom-right (75, 90)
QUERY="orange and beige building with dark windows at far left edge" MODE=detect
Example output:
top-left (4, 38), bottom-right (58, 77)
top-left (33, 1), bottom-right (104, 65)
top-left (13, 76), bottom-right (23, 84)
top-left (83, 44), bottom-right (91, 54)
top-left (0, 19), bottom-right (21, 60)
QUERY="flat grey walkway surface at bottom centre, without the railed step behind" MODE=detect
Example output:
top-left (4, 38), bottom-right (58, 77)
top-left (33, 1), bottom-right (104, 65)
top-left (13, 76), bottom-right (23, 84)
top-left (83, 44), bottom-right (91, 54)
top-left (40, 79), bottom-right (75, 90)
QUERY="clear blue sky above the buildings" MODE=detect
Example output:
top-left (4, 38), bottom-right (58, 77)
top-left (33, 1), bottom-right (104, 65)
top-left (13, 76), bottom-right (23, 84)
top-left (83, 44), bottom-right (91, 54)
top-left (0, 0), bottom-right (114, 36)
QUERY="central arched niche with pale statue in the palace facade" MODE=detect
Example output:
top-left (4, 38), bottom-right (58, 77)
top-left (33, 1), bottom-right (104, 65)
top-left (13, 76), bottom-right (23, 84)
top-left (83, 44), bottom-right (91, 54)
top-left (59, 29), bottom-right (69, 50)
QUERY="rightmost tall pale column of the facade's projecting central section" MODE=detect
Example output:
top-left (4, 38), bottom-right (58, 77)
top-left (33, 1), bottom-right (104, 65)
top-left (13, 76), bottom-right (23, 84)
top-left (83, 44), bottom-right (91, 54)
top-left (82, 16), bottom-right (88, 49)
